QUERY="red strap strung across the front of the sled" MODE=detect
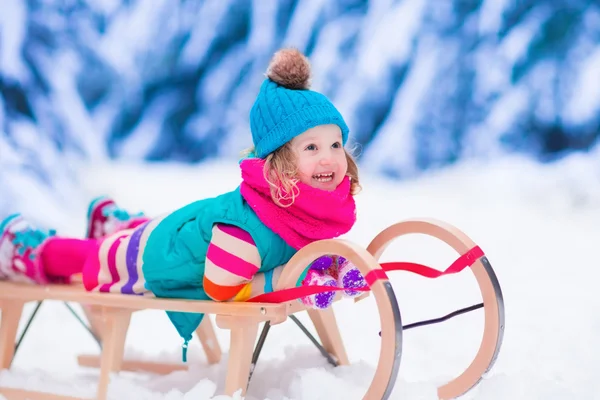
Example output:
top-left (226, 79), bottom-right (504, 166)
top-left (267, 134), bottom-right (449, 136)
top-left (247, 246), bottom-right (484, 303)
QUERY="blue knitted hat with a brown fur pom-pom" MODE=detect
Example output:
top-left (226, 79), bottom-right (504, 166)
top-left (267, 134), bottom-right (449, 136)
top-left (250, 49), bottom-right (348, 158)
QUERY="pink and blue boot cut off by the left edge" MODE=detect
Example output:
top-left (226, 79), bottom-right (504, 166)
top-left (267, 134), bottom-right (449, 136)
top-left (0, 214), bottom-right (55, 284)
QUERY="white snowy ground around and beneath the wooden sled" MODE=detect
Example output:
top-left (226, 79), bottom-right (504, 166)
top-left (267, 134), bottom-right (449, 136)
top-left (0, 154), bottom-right (600, 400)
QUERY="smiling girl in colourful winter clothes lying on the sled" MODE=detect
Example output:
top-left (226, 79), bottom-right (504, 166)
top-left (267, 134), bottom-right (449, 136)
top-left (0, 49), bottom-right (365, 356)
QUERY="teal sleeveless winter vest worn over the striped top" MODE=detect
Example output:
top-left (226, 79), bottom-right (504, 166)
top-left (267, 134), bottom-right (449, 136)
top-left (142, 187), bottom-right (296, 356)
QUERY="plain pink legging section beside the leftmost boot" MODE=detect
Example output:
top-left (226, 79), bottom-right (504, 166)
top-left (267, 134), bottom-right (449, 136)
top-left (41, 237), bottom-right (97, 278)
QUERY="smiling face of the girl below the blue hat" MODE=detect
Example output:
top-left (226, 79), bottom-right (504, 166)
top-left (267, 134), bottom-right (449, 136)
top-left (291, 124), bottom-right (348, 191)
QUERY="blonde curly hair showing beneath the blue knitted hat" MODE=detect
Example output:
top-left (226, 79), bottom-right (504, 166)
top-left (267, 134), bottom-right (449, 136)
top-left (242, 142), bottom-right (362, 207)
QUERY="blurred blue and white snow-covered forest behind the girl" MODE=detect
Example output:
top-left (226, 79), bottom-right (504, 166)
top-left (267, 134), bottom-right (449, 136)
top-left (0, 0), bottom-right (600, 223)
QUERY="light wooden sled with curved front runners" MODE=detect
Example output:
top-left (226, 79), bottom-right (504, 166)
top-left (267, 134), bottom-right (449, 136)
top-left (0, 220), bottom-right (504, 400)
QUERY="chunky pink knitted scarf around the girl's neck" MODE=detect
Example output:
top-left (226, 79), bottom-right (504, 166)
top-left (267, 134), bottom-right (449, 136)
top-left (240, 158), bottom-right (356, 249)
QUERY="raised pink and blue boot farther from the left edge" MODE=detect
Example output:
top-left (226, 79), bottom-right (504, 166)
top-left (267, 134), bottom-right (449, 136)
top-left (86, 196), bottom-right (149, 239)
